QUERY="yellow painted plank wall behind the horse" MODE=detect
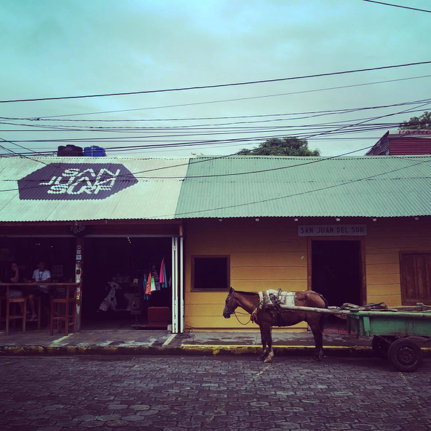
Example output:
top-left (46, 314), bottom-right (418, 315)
top-left (184, 218), bottom-right (431, 330)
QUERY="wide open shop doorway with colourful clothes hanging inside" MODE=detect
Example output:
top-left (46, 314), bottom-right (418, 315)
top-left (82, 237), bottom-right (172, 330)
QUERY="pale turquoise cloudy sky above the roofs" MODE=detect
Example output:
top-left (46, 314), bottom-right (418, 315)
top-left (0, 0), bottom-right (431, 157)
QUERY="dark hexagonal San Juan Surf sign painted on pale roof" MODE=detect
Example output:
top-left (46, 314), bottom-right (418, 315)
top-left (18, 163), bottom-right (138, 200)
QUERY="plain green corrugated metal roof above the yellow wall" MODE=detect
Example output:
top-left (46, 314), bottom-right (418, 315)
top-left (176, 156), bottom-right (431, 218)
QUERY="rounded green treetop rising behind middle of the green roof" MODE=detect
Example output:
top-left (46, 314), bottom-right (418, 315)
top-left (237, 137), bottom-right (320, 156)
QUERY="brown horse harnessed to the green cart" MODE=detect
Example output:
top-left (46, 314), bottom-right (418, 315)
top-left (223, 287), bottom-right (328, 362)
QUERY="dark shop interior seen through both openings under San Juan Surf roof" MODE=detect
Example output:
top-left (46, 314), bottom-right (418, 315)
top-left (0, 237), bottom-right (172, 329)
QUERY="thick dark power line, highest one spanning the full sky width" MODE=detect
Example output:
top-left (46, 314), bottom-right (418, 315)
top-left (0, 60), bottom-right (431, 103)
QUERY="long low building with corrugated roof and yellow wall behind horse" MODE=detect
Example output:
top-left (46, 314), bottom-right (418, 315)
top-left (0, 156), bottom-right (431, 332)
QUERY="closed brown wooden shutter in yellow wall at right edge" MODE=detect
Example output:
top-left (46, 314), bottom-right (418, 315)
top-left (400, 252), bottom-right (431, 305)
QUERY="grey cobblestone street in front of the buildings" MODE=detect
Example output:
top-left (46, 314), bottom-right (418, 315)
top-left (0, 356), bottom-right (431, 431)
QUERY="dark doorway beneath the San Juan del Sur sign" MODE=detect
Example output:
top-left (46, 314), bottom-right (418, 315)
top-left (311, 241), bottom-right (362, 306)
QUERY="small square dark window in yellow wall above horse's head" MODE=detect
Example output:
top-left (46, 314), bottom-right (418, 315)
top-left (192, 256), bottom-right (230, 291)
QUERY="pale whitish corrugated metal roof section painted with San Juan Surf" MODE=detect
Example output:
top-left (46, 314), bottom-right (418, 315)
top-left (0, 157), bottom-right (189, 222)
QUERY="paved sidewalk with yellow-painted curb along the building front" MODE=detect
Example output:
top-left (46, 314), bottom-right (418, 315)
top-left (0, 329), bottom-right (382, 356)
